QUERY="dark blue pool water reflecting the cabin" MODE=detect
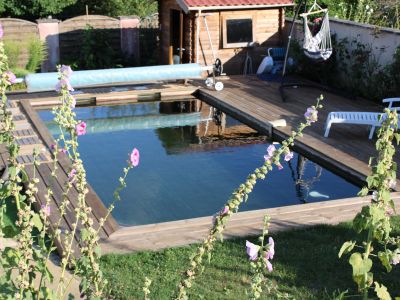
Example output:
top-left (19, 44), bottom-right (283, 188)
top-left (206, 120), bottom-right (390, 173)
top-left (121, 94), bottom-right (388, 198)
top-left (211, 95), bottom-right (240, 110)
top-left (39, 100), bottom-right (359, 225)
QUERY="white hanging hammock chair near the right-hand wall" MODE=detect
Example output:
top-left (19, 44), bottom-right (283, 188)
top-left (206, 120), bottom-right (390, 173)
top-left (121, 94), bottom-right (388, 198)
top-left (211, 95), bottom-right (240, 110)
top-left (300, 1), bottom-right (332, 61)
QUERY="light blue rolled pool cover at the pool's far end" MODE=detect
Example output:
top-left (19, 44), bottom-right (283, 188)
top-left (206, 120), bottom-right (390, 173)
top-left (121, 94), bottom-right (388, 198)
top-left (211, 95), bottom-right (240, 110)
top-left (25, 64), bottom-right (204, 93)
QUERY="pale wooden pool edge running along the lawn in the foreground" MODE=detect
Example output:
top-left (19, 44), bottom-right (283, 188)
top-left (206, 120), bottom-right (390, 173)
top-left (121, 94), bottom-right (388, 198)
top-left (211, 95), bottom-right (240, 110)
top-left (101, 193), bottom-right (400, 253)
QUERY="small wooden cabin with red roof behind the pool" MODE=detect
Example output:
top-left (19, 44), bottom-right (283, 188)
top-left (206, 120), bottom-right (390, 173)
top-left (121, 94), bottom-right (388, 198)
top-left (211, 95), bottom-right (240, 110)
top-left (158, 0), bottom-right (293, 75)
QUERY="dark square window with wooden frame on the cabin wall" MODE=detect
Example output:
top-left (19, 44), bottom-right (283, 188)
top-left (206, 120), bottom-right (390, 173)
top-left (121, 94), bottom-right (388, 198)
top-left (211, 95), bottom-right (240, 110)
top-left (222, 16), bottom-right (254, 48)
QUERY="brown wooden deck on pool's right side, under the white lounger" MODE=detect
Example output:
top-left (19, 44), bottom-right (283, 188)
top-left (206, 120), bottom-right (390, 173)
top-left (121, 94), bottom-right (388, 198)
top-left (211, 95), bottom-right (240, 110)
top-left (197, 76), bottom-right (400, 186)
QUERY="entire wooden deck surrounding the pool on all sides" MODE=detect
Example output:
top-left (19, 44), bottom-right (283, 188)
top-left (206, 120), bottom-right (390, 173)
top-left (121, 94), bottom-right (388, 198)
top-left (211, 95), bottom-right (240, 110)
top-left (0, 76), bottom-right (400, 253)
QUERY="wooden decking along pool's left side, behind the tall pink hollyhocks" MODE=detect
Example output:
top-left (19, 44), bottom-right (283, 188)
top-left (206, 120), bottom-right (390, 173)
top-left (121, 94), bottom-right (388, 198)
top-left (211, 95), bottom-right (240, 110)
top-left (0, 101), bottom-right (119, 257)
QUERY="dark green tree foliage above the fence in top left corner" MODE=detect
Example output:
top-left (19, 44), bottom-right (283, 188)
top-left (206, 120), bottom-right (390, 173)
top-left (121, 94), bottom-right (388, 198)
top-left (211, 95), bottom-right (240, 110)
top-left (0, 0), bottom-right (77, 20)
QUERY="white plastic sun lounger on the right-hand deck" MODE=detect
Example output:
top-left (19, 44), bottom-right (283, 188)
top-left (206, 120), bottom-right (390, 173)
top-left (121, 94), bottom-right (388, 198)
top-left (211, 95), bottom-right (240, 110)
top-left (324, 98), bottom-right (400, 139)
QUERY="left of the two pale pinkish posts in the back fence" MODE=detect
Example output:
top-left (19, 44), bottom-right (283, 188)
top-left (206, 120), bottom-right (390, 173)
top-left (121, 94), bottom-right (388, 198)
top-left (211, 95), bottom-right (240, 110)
top-left (37, 19), bottom-right (60, 72)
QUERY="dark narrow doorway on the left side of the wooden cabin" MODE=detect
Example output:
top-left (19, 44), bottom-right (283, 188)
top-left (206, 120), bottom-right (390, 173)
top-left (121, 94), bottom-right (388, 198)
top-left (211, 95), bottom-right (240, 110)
top-left (169, 9), bottom-right (185, 65)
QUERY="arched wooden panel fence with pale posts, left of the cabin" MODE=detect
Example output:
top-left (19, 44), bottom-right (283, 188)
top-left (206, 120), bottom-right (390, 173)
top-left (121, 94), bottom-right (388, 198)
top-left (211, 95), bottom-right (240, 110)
top-left (0, 14), bottom-right (158, 72)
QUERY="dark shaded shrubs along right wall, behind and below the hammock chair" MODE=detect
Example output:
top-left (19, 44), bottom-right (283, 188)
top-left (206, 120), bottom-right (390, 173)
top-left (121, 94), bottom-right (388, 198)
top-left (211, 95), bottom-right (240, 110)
top-left (290, 36), bottom-right (400, 103)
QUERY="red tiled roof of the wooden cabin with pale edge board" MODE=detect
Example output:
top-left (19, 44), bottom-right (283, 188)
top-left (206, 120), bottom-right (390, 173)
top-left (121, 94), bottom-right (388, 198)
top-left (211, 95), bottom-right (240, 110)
top-left (177, 0), bottom-right (293, 12)
